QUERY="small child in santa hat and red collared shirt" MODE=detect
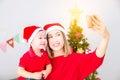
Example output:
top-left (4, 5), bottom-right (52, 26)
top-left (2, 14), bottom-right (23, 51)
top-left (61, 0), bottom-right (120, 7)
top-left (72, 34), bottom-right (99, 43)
top-left (17, 25), bottom-right (52, 80)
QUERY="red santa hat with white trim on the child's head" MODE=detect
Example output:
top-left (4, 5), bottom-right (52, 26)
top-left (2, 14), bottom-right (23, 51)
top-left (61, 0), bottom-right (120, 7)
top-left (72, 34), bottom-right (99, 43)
top-left (23, 25), bottom-right (43, 44)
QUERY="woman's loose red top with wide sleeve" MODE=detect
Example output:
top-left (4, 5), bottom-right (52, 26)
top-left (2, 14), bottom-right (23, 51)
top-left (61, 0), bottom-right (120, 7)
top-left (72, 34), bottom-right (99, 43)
top-left (46, 51), bottom-right (103, 80)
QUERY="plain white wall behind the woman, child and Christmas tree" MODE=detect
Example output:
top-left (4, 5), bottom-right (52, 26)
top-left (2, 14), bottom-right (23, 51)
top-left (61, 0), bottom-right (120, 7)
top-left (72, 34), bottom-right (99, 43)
top-left (0, 0), bottom-right (120, 80)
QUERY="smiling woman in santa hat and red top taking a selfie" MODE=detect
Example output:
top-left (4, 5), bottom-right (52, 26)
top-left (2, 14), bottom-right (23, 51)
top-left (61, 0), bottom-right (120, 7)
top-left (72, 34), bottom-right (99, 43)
top-left (44, 15), bottom-right (110, 80)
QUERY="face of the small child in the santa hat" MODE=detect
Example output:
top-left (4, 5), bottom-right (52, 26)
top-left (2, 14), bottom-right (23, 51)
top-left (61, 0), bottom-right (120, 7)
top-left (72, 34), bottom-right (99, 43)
top-left (31, 30), bottom-right (47, 50)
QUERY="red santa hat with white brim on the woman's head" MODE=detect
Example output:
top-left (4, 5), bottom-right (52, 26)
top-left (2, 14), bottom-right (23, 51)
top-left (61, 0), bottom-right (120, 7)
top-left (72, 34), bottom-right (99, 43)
top-left (44, 23), bottom-right (66, 34)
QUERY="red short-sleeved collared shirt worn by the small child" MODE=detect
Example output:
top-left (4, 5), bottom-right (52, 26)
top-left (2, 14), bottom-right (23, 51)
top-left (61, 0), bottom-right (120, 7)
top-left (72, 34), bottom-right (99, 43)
top-left (18, 48), bottom-right (50, 80)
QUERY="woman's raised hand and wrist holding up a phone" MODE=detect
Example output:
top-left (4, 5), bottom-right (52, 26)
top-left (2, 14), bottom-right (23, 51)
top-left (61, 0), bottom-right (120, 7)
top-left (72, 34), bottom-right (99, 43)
top-left (87, 15), bottom-right (110, 38)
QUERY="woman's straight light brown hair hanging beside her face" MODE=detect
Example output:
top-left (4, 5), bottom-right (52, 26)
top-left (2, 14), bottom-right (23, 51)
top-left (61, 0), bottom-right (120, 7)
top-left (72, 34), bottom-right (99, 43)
top-left (47, 31), bottom-right (71, 58)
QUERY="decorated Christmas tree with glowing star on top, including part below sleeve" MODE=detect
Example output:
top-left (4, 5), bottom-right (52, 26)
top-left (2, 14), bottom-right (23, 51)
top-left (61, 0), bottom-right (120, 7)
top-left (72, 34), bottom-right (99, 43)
top-left (68, 7), bottom-right (100, 80)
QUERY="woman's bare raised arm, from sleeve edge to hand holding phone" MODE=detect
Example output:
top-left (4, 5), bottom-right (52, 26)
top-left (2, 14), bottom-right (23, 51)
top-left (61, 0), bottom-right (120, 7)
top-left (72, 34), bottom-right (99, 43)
top-left (87, 15), bottom-right (110, 58)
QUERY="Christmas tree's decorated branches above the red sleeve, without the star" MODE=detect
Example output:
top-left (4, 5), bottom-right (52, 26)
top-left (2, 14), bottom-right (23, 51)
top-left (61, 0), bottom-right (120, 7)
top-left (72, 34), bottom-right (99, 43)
top-left (68, 19), bottom-right (89, 53)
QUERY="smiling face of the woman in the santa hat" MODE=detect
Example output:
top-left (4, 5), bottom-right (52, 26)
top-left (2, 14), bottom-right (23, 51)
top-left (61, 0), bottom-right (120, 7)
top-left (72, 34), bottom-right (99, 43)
top-left (48, 29), bottom-right (64, 51)
